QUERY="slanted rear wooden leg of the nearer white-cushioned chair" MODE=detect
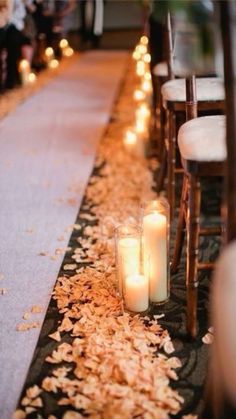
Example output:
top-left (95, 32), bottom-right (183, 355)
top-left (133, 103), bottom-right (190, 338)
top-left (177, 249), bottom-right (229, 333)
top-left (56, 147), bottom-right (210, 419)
top-left (171, 175), bottom-right (188, 273)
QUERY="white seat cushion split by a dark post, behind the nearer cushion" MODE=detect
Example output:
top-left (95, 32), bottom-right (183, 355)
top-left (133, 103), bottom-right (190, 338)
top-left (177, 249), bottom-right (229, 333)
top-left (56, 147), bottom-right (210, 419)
top-left (161, 77), bottom-right (225, 102)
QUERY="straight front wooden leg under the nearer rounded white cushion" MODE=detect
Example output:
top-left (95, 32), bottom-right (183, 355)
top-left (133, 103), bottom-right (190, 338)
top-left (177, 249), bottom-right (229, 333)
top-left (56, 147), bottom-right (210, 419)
top-left (186, 175), bottom-right (201, 338)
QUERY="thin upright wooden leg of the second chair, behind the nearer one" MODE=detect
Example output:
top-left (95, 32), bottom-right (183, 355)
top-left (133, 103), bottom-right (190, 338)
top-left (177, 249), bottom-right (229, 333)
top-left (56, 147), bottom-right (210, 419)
top-left (167, 111), bottom-right (176, 220)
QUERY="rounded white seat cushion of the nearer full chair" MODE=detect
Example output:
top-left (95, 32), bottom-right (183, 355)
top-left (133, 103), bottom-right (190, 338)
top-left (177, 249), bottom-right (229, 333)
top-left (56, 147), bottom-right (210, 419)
top-left (178, 115), bottom-right (226, 162)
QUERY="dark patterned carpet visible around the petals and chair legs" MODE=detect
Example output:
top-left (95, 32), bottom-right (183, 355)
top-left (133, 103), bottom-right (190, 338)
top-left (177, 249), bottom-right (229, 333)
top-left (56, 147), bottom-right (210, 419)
top-left (19, 69), bottom-right (221, 419)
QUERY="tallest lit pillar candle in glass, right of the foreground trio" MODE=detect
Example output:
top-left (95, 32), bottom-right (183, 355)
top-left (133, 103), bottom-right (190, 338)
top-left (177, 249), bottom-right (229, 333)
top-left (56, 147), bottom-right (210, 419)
top-left (142, 198), bottom-right (169, 303)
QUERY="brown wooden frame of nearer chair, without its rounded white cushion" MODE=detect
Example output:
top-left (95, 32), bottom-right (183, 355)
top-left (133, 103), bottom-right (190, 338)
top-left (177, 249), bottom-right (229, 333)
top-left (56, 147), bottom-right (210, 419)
top-left (171, 76), bottom-right (225, 338)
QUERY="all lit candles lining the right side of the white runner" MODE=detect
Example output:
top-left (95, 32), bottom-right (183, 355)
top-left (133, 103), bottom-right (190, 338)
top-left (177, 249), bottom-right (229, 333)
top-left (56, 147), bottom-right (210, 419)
top-left (115, 36), bottom-right (170, 314)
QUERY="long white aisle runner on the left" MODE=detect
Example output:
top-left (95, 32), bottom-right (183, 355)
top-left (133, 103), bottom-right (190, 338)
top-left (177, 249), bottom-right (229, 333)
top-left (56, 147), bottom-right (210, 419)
top-left (0, 52), bottom-right (127, 419)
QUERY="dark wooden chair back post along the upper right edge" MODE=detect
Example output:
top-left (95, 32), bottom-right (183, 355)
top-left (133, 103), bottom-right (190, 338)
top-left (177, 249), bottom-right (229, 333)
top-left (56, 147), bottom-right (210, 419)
top-left (220, 0), bottom-right (236, 242)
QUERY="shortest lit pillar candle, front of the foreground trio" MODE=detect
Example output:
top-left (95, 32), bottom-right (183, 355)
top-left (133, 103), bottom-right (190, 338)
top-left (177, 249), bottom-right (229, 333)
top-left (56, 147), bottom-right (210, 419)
top-left (124, 274), bottom-right (149, 313)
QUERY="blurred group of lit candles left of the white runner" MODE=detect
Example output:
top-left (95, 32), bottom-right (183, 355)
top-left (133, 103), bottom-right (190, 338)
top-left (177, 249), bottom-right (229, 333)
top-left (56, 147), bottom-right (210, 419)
top-left (19, 39), bottom-right (74, 86)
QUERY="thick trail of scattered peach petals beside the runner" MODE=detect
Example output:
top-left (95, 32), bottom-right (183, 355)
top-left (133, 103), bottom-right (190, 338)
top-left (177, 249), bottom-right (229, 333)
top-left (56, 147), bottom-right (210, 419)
top-left (16, 60), bottom-right (183, 419)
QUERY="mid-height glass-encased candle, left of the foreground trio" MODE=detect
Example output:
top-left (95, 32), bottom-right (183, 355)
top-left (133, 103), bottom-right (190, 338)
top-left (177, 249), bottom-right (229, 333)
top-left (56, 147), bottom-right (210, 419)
top-left (115, 224), bottom-right (141, 295)
